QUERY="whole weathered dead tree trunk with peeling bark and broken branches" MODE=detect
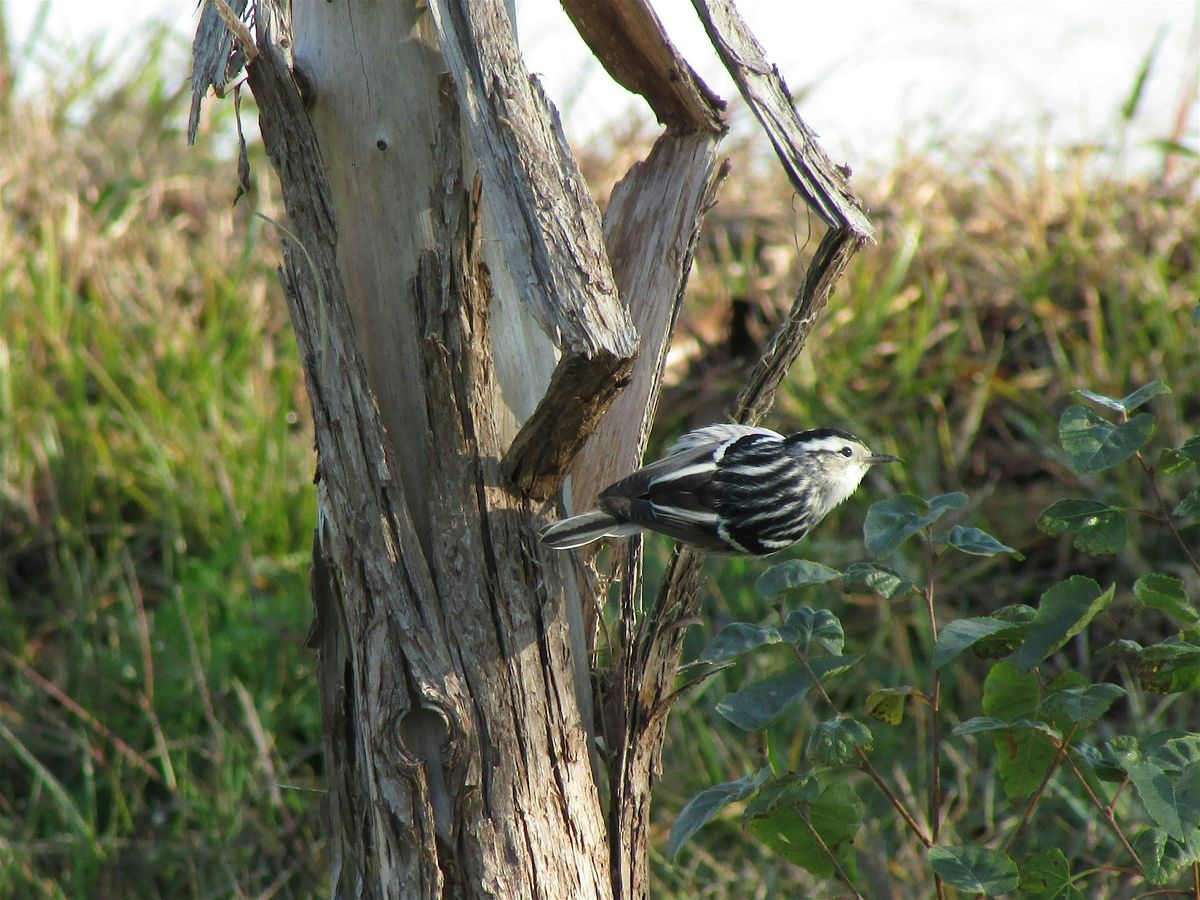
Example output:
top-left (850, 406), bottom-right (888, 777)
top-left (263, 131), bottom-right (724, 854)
top-left (191, 0), bottom-right (870, 898)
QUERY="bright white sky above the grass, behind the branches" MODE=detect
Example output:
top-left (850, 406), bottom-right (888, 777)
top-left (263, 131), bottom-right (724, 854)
top-left (2, 0), bottom-right (1200, 166)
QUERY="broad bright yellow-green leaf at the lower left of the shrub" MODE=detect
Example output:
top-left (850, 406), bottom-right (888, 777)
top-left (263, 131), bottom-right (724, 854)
top-left (746, 781), bottom-right (863, 878)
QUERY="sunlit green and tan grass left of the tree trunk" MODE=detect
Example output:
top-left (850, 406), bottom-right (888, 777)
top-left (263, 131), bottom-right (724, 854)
top-left (0, 26), bottom-right (324, 896)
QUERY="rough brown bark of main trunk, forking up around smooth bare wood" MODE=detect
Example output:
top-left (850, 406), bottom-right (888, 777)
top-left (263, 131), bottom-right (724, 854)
top-left (238, 10), bottom-right (611, 898)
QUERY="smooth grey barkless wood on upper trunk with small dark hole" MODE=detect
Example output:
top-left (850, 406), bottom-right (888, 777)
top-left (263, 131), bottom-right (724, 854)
top-left (292, 2), bottom-right (443, 542)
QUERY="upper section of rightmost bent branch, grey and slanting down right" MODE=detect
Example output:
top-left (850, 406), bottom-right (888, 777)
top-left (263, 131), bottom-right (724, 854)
top-left (692, 0), bottom-right (875, 240)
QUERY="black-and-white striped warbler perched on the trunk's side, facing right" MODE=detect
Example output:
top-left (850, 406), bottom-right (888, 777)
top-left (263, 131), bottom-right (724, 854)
top-left (539, 425), bottom-right (898, 556)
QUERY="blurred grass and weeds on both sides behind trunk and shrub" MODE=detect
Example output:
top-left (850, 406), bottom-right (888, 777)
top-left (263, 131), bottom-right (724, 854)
top-left (0, 7), bottom-right (1200, 898)
